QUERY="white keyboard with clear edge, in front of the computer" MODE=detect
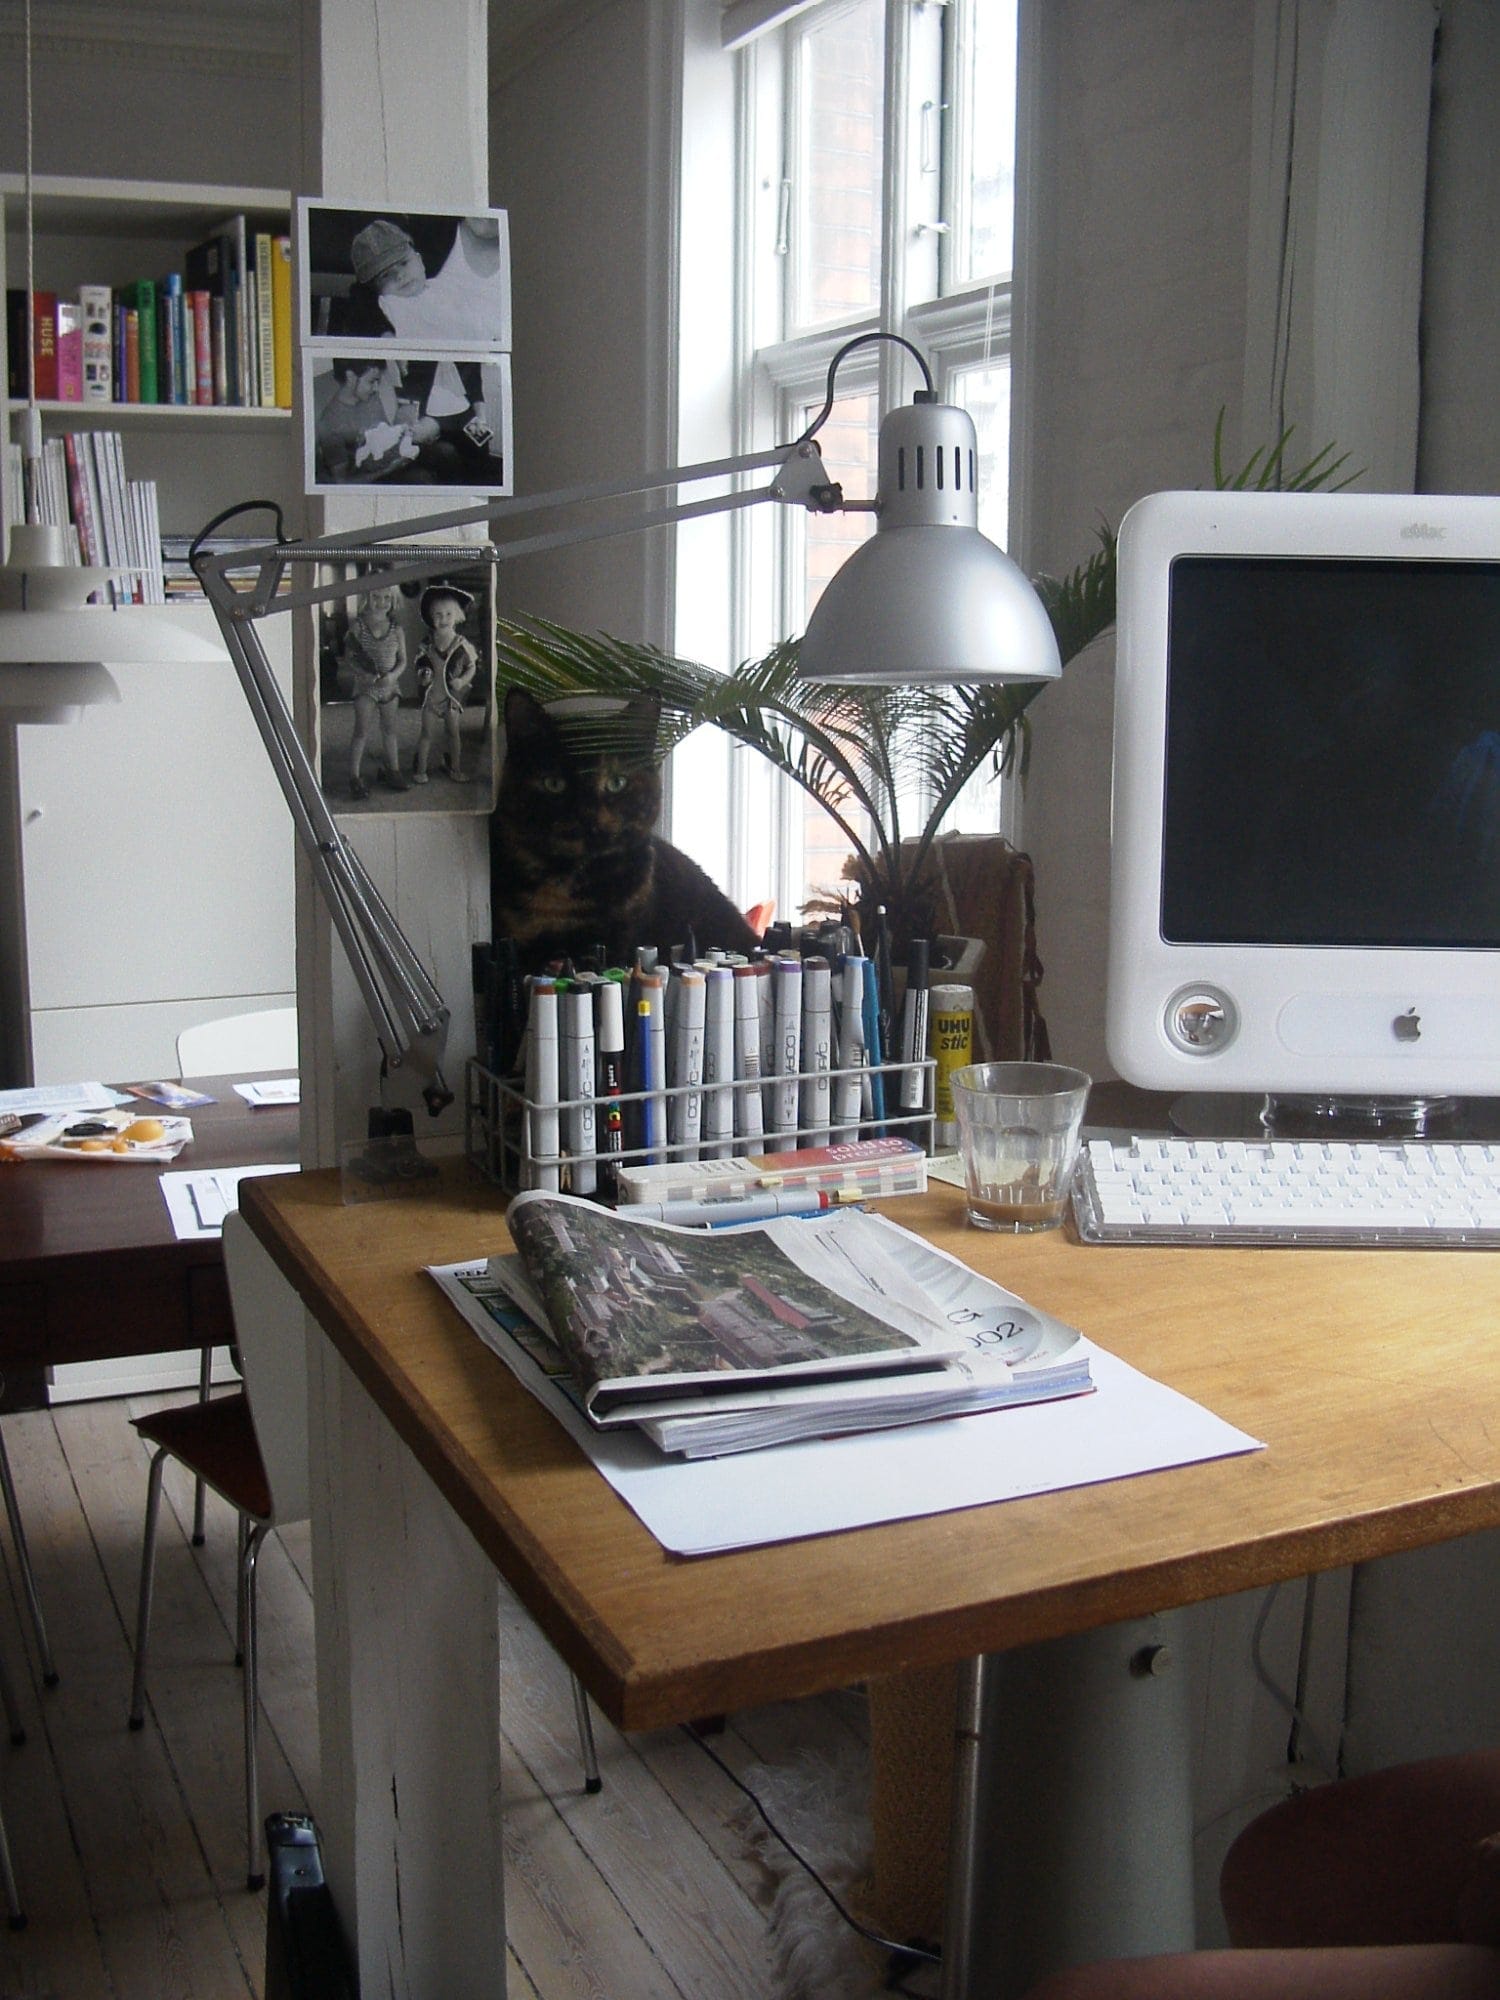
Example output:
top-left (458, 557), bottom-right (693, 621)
top-left (1072, 1138), bottom-right (1500, 1250)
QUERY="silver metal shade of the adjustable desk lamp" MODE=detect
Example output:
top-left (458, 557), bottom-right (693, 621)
top-left (798, 402), bottom-right (1062, 684)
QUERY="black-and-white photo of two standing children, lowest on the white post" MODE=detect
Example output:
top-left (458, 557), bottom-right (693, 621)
top-left (316, 564), bottom-right (496, 814)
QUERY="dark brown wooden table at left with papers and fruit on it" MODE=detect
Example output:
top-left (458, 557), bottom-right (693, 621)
top-left (0, 1076), bottom-right (298, 1408)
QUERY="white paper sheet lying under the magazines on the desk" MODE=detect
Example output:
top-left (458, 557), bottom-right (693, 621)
top-left (432, 1262), bottom-right (1264, 1556)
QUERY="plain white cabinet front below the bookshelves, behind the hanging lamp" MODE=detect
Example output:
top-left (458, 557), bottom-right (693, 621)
top-left (0, 604), bottom-right (294, 1082)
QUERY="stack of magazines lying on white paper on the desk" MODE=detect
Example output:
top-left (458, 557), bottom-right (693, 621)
top-left (430, 1192), bottom-right (1092, 1458)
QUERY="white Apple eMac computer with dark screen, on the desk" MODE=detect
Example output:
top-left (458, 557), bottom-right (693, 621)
top-left (1108, 492), bottom-right (1500, 1100)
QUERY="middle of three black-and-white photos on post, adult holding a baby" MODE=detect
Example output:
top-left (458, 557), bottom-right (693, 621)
top-left (302, 348), bottom-right (512, 496)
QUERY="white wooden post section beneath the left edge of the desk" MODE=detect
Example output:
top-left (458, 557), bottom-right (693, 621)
top-left (308, 1330), bottom-right (506, 2000)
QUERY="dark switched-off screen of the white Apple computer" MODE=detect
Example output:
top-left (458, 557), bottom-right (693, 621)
top-left (1162, 556), bottom-right (1500, 950)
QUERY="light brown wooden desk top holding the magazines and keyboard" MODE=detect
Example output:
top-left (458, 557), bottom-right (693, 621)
top-left (244, 1164), bottom-right (1500, 1728)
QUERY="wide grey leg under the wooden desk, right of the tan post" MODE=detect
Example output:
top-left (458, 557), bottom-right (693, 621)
top-left (942, 1612), bottom-right (1194, 2000)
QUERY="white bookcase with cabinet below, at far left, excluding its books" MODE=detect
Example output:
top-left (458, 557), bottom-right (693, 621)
top-left (0, 174), bottom-right (302, 1084)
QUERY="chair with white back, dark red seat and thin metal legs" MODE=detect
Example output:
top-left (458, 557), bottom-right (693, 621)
top-left (130, 1214), bottom-right (598, 1890)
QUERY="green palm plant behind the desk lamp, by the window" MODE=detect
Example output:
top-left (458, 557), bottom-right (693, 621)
top-left (498, 412), bottom-right (1348, 952)
